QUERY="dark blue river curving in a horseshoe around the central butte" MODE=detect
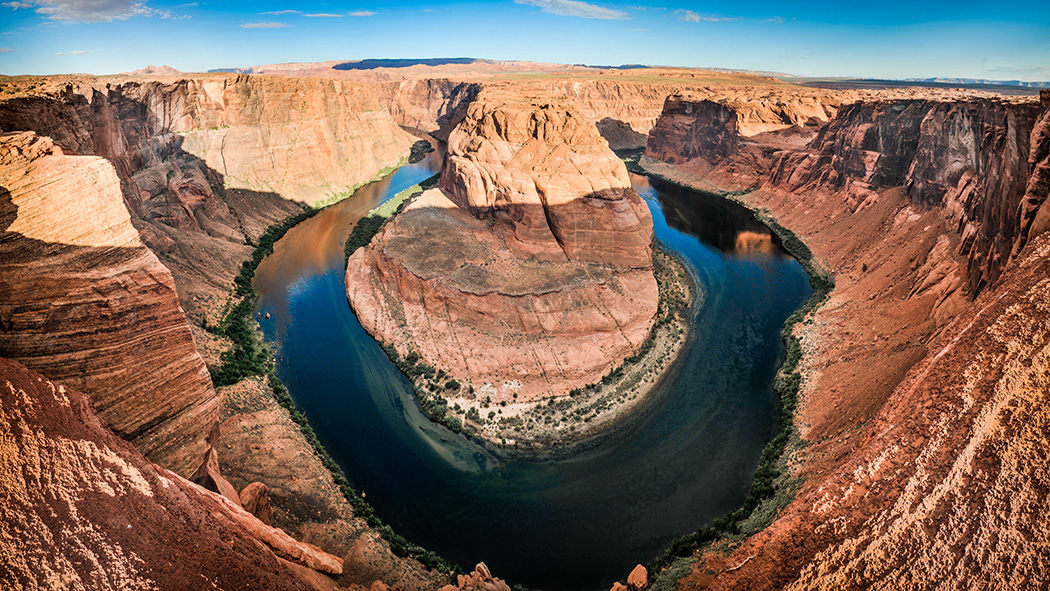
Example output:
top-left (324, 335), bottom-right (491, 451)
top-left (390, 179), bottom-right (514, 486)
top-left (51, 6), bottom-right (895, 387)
top-left (255, 154), bottom-right (811, 590)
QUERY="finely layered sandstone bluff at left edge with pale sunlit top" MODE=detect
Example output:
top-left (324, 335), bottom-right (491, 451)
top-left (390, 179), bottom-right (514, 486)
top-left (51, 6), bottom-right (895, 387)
top-left (0, 132), bottom-right (218, 469)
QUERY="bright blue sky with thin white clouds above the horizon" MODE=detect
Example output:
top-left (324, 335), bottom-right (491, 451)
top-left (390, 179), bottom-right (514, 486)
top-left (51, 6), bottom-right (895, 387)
top-left (0, 0), bottom-right (1050, 81)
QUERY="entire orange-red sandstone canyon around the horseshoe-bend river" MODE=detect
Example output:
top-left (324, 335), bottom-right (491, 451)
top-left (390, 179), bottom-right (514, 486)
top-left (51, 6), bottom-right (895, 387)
top-left (0, 62), bottom-right (1050, 589)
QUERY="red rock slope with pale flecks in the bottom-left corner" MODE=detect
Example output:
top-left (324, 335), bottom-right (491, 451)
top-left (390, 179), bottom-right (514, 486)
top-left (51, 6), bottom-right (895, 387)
top-left (0, 359), bottom-right (341, 590)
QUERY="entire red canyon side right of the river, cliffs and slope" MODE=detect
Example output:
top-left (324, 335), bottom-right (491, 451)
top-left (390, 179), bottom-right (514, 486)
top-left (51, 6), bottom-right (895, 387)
top-left (638, 86), bottom-right (1050, 589)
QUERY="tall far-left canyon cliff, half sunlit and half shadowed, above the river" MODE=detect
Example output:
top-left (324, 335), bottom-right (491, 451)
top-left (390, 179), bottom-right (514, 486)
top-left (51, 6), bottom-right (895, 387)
top-left (0, 76), bottom-right (414, 322)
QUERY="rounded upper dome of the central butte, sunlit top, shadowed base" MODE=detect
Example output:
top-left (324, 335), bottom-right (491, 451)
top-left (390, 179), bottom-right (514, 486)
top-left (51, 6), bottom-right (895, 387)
top-left (441, 102), bottom-right (652, 268)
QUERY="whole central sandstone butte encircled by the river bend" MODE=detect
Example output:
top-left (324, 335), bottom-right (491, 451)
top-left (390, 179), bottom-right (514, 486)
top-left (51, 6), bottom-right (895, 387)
top-left (347, 100), bottom-right (658, 401)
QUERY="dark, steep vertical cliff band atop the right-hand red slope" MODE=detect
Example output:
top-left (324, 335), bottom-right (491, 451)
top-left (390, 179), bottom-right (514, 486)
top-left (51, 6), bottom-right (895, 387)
top-left (771, 99), bottom-right (1037, 292)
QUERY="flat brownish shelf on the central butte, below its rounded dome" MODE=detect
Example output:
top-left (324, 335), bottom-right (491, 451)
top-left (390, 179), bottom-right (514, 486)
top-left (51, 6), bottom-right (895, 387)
top-left (383, 189), bottom-right (611, 295)
